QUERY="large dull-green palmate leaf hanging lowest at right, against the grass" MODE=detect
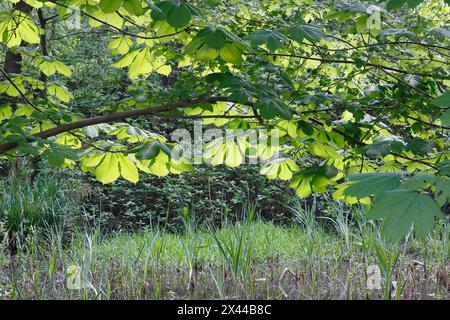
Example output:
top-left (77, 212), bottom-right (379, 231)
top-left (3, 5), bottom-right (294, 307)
top-left (369, 190), bottom-right (442, 241)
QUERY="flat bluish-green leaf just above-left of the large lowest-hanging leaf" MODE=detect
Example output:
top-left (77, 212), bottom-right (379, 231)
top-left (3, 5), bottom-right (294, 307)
top-left (344, 173), bottom-right (401, 198)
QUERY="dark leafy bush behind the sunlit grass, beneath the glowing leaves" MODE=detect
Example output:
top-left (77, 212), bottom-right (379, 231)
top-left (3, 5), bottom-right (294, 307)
top-left (80, 166), bottom-right (293, 229)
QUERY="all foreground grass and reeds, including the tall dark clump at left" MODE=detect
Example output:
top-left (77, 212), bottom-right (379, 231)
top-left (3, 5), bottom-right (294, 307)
top-left (0, 172), bottom-right (450, 299)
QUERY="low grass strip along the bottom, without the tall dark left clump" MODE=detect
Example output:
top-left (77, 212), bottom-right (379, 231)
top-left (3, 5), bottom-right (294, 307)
top-left (0, 216), bottom-right (449, 299)
